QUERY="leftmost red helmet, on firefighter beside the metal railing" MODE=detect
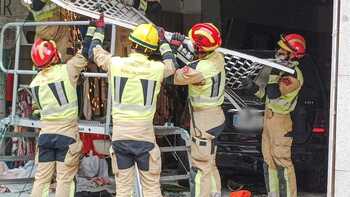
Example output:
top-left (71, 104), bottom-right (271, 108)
top-left (31, 38), bottom-right (60, 68)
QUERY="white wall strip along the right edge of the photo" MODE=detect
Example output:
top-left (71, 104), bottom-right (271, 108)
top-left (328, 0), bottom-right (350, 197)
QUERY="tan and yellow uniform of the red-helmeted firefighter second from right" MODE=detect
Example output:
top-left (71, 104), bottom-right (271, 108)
top-left (174, 51), bottom-right (225, 197)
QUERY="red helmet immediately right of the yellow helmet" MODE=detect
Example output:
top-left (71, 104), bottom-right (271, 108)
top-left (188, 23), bottom-right (222, 52)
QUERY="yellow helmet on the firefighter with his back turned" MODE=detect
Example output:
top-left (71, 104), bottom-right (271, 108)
top-left (129, 24), bottom-right (159, 51)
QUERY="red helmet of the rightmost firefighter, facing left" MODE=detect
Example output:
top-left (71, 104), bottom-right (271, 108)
top-left (278, 34), bottom-right (306, 59)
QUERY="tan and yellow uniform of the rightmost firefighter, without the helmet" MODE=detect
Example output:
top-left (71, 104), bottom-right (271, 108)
top-left (256, 66), bottom-right (304, 197)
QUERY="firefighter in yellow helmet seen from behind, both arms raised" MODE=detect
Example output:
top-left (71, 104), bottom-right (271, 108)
top-left (89, 16), bottom-right (177, 197)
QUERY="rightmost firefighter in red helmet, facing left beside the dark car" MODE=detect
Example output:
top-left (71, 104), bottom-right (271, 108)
top-left (242, 34), bottom-right (306, 197)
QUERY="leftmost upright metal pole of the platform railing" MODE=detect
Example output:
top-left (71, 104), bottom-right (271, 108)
top-left (10, 26), bottom-right (21, 120)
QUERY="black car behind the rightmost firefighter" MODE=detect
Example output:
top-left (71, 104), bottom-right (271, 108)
top-left (217, 51), bottom-right (328, 192)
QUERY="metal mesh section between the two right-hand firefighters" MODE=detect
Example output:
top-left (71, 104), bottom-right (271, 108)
top-left (225, 54), bottom-right (264, 89)
